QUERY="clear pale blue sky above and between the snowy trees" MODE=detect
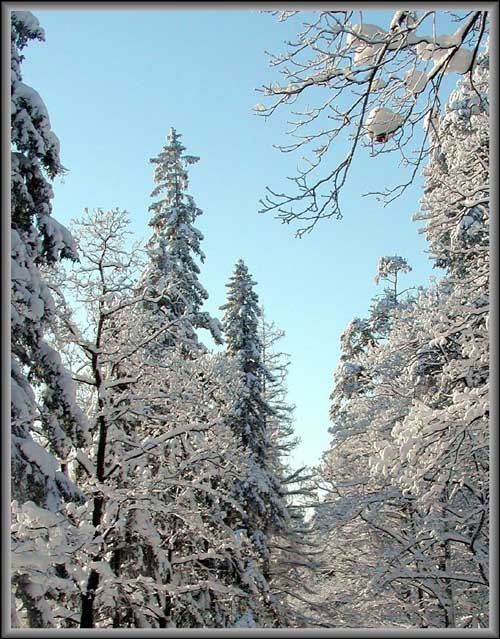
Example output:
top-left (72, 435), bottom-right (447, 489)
top-left (19, 9), bottom-right (456, 464)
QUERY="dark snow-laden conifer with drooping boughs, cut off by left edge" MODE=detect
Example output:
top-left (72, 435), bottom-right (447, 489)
top-left (11, 11), bottom-right (85, 627)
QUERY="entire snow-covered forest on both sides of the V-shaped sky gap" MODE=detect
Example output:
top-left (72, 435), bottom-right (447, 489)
top-left (11, 11), bottom-right (489, 628)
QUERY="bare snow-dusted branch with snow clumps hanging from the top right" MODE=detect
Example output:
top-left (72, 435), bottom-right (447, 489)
top-left (255, 11), bottom-right (488, 236)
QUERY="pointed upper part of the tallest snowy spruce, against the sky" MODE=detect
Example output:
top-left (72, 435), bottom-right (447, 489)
top-left (139, 128), bottom-right (222, 352)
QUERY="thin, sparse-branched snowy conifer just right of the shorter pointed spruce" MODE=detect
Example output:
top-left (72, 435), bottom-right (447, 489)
top-left (258, 307), bottom-right (318, 627)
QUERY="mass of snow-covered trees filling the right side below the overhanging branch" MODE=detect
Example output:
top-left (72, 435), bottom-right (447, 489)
top-left (296, 42), bottom-right (489, 628)
